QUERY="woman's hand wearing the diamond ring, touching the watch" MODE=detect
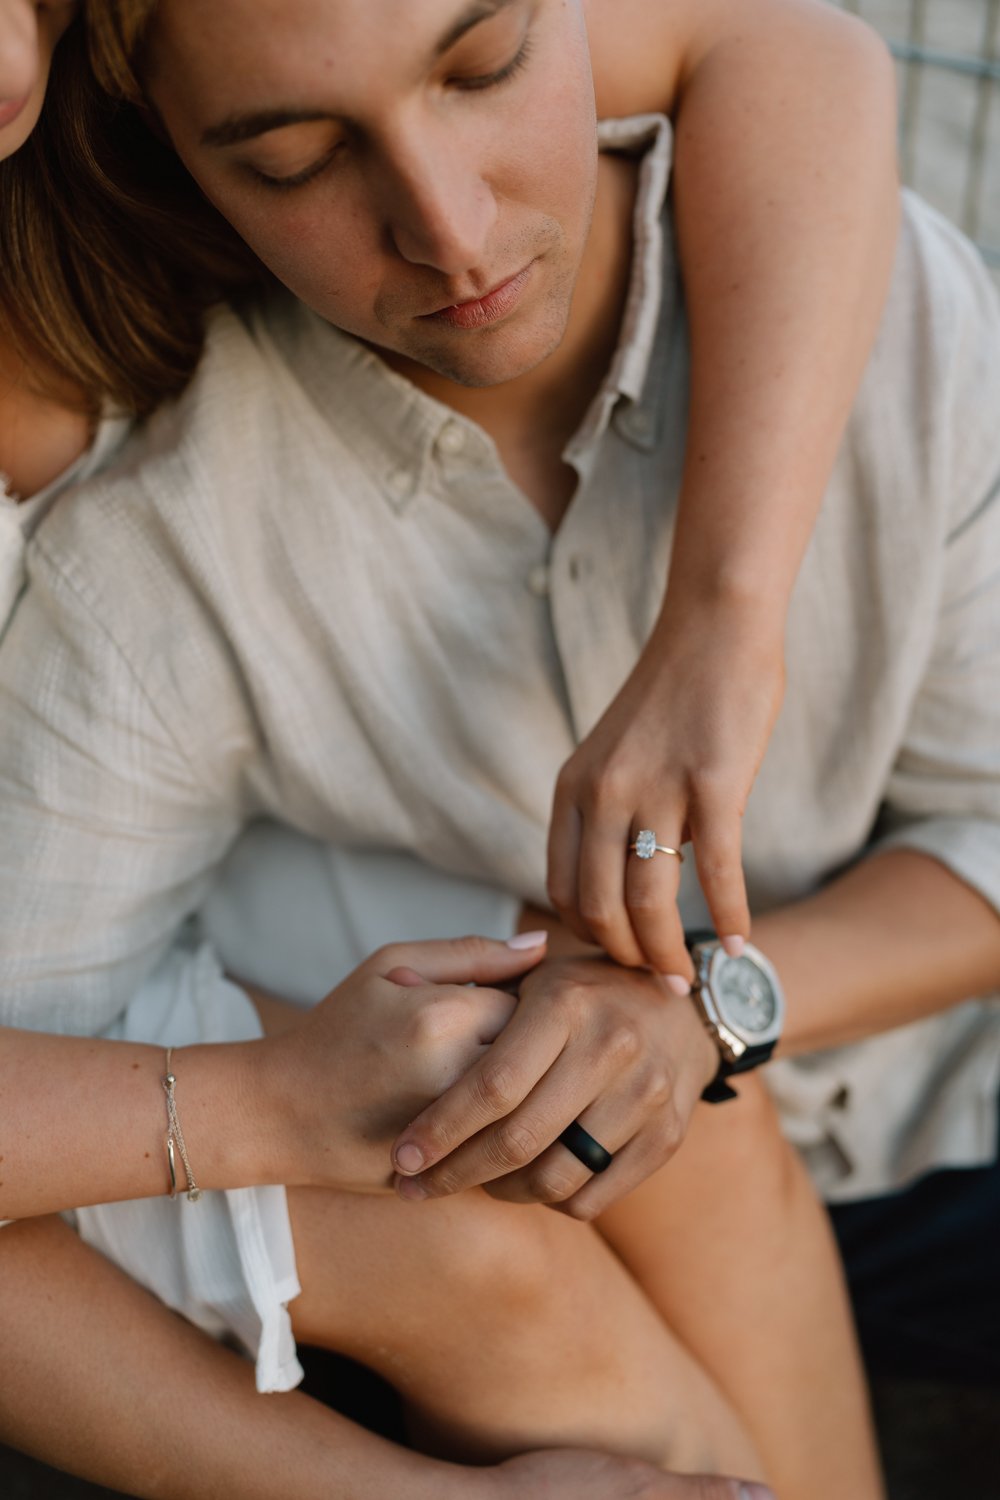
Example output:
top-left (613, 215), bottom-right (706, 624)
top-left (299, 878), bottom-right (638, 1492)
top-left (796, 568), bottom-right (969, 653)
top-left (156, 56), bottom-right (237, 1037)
top-left (549, 603), bottom-right (784, 993)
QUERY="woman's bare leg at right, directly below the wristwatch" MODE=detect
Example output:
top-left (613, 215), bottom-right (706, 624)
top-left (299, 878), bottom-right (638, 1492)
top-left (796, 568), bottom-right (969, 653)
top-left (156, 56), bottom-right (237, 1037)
top-left (598, 1079), bottom-right (883, 1500)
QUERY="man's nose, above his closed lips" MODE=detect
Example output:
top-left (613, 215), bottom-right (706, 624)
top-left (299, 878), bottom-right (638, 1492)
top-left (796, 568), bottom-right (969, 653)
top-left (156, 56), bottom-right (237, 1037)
top-left (381, 126), bottom-right (496, 276)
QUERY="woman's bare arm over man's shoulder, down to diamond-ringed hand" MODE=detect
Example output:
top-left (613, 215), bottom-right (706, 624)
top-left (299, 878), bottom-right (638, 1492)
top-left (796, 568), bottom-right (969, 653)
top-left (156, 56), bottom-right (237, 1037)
top-left (549, 0), bottom-right (898, 981)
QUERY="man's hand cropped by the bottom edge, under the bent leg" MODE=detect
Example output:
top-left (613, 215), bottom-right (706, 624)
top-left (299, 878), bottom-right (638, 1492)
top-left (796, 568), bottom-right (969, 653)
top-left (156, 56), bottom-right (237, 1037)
top-left (477, 1448), bottom-right (774, 1500)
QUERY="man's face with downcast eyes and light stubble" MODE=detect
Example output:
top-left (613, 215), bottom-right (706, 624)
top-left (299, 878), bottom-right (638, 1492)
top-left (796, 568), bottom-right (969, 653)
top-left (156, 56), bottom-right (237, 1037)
top-left (147, 0), bottom-right (597, 386)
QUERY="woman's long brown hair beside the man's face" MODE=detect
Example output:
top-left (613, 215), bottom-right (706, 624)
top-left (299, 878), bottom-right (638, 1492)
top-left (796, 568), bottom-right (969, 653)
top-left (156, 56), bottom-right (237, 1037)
top-left (0, 0), bottom-right (262, 414)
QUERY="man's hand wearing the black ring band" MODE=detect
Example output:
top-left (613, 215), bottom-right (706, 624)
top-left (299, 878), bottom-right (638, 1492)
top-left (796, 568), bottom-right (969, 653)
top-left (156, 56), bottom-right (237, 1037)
top-left (393, 959), bottom-right (718, 1220)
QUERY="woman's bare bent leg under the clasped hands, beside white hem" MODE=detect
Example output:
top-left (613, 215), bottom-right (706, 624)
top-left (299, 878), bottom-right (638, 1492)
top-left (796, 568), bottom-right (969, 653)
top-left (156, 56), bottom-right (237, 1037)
top-left (289, 1190), bottom-right (762, 1478)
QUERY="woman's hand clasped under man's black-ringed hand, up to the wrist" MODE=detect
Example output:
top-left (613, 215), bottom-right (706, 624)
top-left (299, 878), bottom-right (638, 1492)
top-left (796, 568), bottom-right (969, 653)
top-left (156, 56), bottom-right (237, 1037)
top-left (261, 933), bottom-right (546, 1193)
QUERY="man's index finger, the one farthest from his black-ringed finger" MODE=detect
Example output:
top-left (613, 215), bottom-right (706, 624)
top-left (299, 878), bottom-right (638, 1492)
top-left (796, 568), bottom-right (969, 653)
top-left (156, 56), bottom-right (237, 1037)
top-left (393, 1011), bottom-right (567, 1176)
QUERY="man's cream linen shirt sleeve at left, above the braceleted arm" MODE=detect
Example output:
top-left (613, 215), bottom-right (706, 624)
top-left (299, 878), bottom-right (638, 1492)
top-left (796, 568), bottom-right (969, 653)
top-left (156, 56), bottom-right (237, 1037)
top-left (0, 543), bottom-right (243, 1034)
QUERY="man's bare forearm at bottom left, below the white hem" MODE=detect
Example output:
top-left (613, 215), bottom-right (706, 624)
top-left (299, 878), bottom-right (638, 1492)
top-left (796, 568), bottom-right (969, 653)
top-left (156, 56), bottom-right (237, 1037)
top-left (0, 1218), bottom-right (458, 1500)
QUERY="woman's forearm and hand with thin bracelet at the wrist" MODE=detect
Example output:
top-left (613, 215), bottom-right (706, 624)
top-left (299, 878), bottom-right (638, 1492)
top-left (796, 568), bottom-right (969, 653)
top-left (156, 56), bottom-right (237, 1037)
top-left (0, 938), bottom-right (544, 1220)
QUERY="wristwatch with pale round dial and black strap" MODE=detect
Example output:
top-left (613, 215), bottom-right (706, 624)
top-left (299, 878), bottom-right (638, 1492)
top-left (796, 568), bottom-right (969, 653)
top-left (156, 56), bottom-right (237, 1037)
top-left (684, 930), bottom-right (784, 1104)
